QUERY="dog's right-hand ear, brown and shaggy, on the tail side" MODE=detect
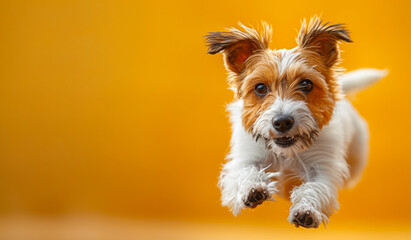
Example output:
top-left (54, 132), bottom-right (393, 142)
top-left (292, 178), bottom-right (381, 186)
top-left (297, 16), bottom-right (352, 67)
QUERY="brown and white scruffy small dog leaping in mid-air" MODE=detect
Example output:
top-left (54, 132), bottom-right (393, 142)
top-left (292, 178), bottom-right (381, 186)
top-left (205, 16), bottom-right (386, 228)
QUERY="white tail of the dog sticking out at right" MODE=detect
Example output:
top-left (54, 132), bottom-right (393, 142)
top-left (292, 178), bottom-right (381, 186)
top-left (340, 68), bottom-right (388, 94)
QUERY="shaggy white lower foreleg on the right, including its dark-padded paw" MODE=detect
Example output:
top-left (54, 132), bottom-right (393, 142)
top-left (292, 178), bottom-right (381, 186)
top-left (288, 170), bottom-right (339, 228)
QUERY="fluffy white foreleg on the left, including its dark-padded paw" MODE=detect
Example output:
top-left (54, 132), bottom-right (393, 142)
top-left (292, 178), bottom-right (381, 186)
top-left (219, 159), bottom-right (278, 215)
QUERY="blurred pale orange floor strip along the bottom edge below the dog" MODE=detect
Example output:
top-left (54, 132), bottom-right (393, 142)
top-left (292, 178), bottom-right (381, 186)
top-left (0, 216), bottom-right (411, 240)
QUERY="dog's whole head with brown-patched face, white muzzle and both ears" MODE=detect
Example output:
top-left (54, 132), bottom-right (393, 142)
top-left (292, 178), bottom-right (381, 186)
top-left (206, 17), bottom-right (351, 156)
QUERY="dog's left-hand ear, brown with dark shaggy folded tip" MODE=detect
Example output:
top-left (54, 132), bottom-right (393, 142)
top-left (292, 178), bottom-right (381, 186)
top-left (205, 22), bottom-right (272, 74)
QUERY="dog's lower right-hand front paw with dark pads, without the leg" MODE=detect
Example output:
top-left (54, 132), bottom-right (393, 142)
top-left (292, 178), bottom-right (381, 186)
top-left (288, 205), bottom-right (322, 228)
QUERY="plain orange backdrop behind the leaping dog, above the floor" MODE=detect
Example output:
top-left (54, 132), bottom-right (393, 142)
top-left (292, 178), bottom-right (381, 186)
top-left (0, 0), bottom-right (411, 238)
